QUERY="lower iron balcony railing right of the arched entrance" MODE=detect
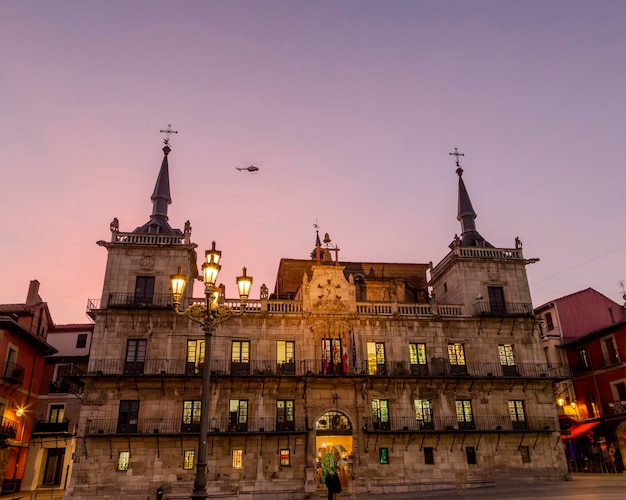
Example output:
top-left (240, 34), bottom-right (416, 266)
top-left (363, 415), bottom-right (559, 432)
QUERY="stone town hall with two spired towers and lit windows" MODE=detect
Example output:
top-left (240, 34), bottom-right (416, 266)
top-left (67, 144), bottom-right (568, 500)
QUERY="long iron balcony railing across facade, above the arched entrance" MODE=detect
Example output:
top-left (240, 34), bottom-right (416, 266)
top-left (88, 359), bottom-right (571, 380)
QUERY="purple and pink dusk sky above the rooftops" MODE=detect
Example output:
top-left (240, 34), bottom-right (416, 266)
top-left (0, 0), bottom-right (626, 324)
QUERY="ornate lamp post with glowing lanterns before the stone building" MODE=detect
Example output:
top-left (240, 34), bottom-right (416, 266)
top-left (170, 242), bottom-right (252, 499)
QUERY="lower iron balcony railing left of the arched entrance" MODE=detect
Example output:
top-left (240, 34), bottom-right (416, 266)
top-left (85, 417), bottom-right (310, 436)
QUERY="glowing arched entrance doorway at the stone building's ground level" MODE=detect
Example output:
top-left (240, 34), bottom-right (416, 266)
top-left (315, 411), bottom-right (352, 490)
